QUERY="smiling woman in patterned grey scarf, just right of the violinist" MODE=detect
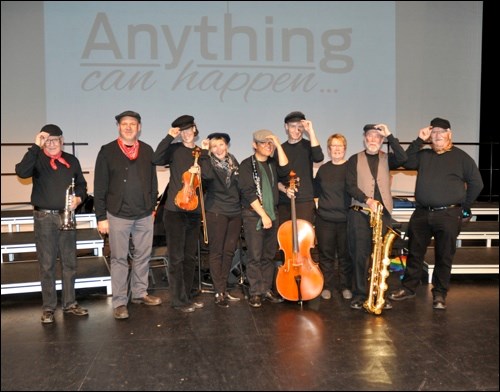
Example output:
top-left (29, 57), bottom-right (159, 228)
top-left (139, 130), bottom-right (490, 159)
top-left (200, 132), bottom-right (241, 308)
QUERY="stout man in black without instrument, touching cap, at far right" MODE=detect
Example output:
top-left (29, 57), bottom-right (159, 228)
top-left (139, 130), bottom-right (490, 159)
top-left (389, 117), bottom-right (483, 310)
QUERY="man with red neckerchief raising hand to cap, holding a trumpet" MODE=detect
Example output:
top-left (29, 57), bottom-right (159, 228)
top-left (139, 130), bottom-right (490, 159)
top-left (16, 124), bottom-right (88, 324)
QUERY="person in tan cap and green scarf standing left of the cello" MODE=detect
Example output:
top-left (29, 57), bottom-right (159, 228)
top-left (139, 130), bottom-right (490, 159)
top-left (240, 129), bottom-right (290, 308)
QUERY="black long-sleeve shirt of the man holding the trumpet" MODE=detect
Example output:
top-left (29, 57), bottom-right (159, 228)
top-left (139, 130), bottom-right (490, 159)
top-left (16, 144), bottom-right (87, 210)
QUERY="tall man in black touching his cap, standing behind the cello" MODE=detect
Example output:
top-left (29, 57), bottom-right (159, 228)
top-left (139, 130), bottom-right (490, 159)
top-left (278, 111), bottom-right (325, 225)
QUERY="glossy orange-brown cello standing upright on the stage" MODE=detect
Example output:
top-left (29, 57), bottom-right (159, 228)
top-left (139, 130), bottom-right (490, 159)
top-left (276, 170), bottom-right (324, 304)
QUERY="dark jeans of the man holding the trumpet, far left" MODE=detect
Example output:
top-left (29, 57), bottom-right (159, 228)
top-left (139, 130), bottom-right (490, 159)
top-left (33, 211), bottom-right (76, 311)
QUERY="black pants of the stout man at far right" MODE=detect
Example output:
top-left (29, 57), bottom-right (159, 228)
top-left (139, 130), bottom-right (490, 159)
top-left (402, 207), bottom-right (462, 297)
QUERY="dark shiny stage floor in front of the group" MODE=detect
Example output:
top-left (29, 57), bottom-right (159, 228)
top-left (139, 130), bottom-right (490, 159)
top-left (1, 269), bottom-right (499, 391)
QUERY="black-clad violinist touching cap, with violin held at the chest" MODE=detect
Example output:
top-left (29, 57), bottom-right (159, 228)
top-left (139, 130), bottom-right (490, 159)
top-left (153, 114), bottom-right (203, 313)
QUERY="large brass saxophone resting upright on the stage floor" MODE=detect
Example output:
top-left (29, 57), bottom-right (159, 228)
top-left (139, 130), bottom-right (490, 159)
top-left (355, 202), bottom-right (400, 315)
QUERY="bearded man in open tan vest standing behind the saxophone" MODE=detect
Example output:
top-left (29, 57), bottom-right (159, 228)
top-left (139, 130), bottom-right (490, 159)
top-left (346, 124), bottom-right (406, 310)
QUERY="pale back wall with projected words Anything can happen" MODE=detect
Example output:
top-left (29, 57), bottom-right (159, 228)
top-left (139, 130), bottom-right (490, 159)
top-left (1, 1), bottom-right (482, 208)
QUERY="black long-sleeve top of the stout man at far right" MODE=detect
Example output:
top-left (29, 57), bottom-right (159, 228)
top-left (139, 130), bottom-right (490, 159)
top-left (404, 138), bottom-right (483, 209)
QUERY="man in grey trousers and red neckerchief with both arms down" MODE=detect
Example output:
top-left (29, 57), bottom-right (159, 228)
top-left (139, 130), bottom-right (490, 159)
top-left (94, 110), bottom-right (162, 320)
